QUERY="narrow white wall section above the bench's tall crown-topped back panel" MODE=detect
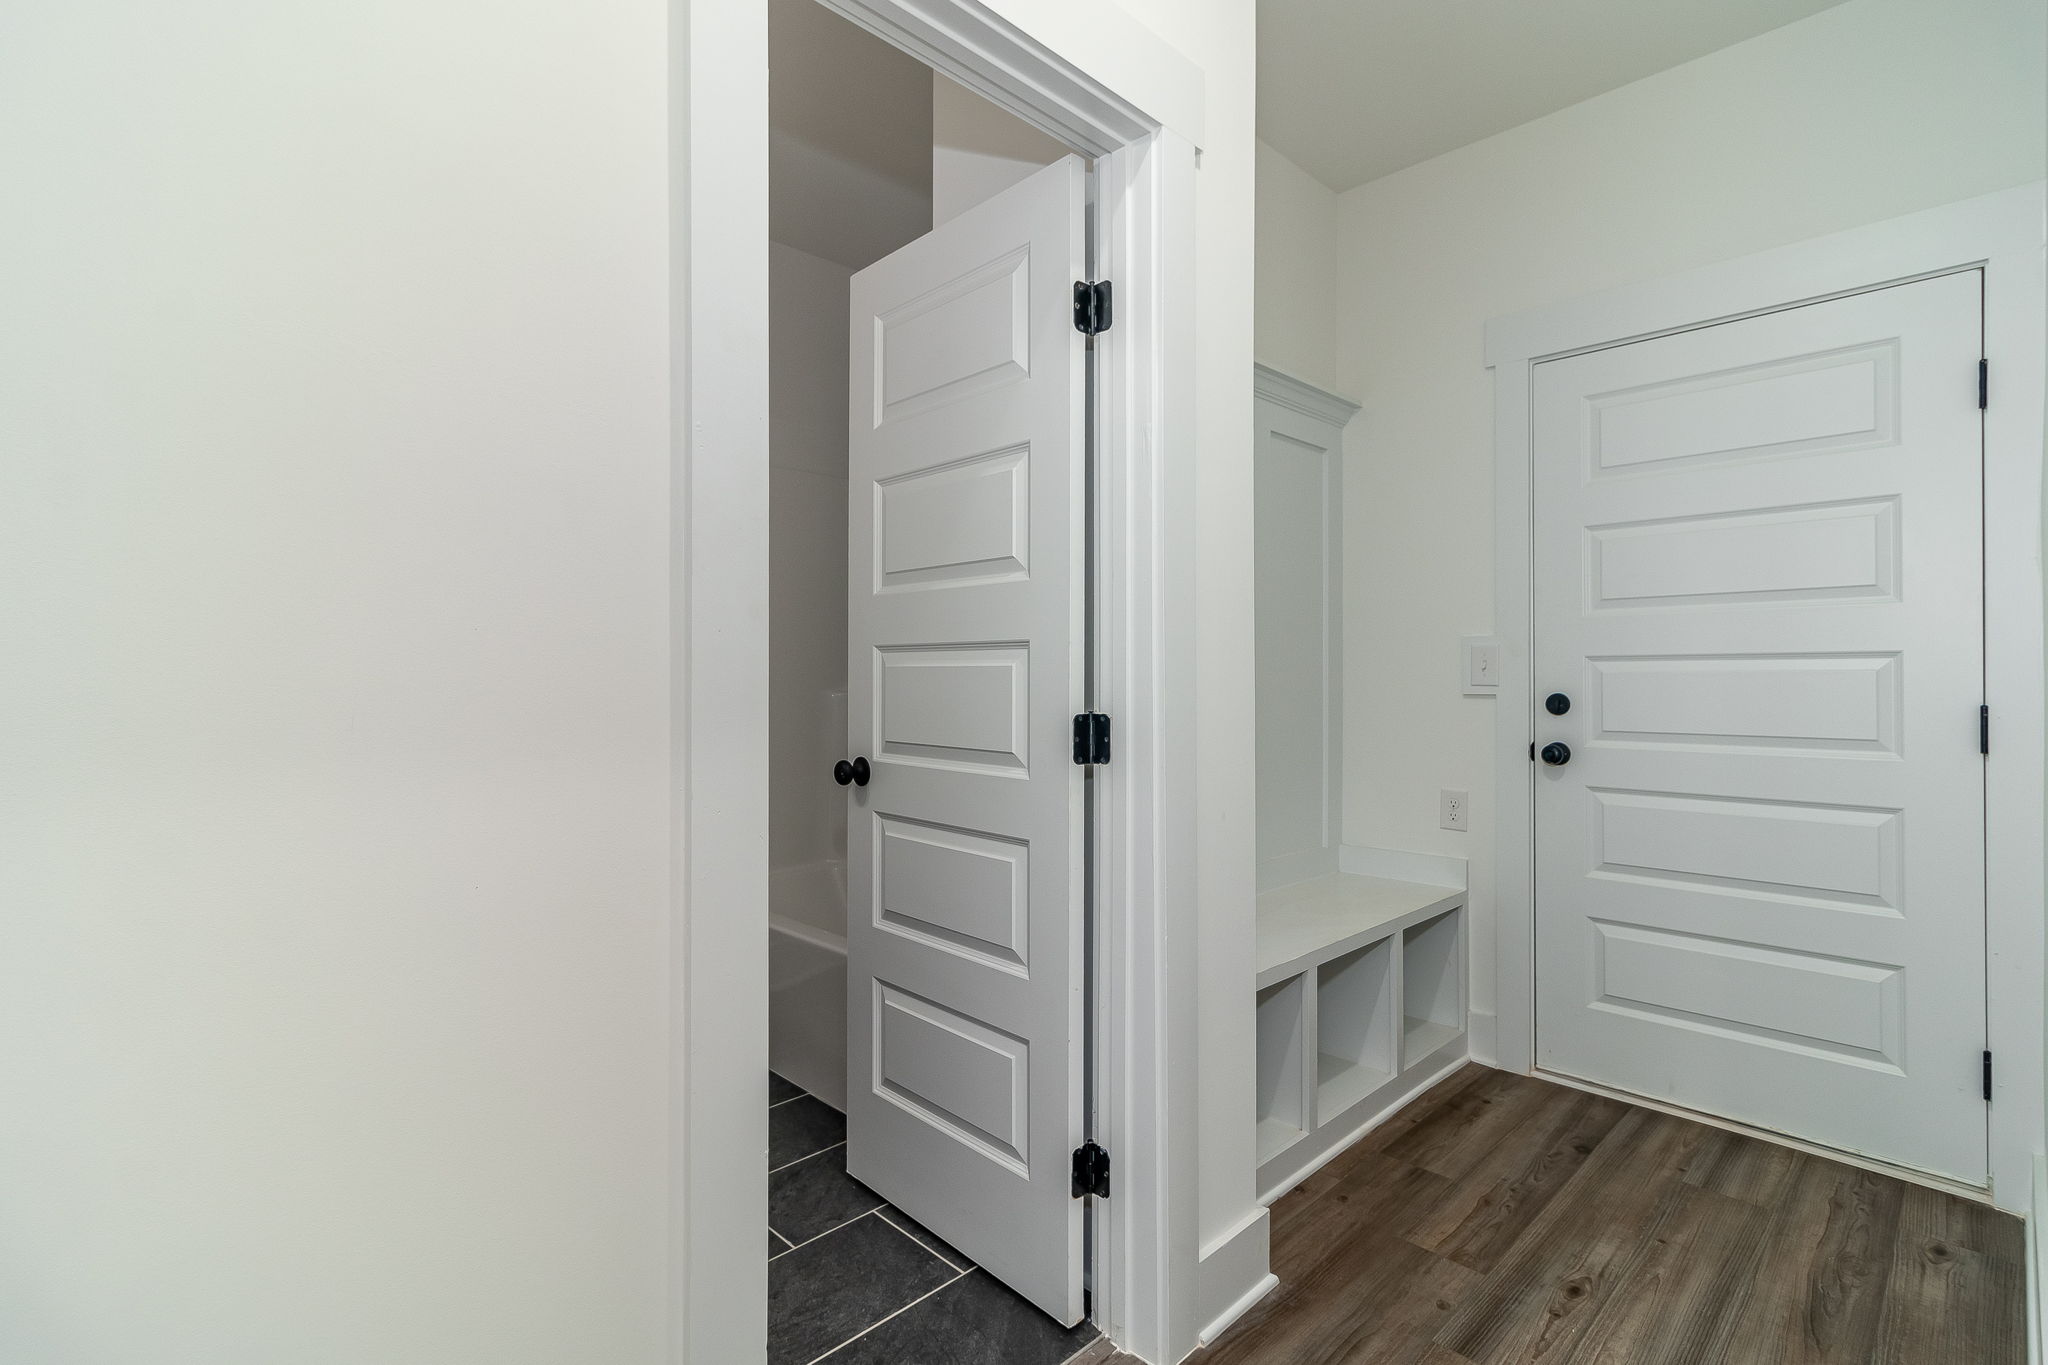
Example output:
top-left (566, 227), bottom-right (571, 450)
top-left (1245, 141), bottom-right (1350, 397)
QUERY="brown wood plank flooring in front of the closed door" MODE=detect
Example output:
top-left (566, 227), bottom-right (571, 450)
top-left (1192, 1066), bottom-right (2025, 1365)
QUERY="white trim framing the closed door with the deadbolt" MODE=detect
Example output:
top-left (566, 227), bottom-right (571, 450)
top-left (1473, 182), bottom-right (2048, 1212)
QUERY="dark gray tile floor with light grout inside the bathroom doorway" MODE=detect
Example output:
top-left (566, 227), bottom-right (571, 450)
top-left (768, 1074), bottom-right (1096, 1365)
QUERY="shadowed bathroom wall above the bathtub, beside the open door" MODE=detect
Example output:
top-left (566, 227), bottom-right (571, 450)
top-left (768, 241), bottom-right (852, 868)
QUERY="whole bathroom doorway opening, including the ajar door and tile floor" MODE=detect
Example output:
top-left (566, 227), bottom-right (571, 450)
top-left (766, 0), bottom-right (1098, 1365)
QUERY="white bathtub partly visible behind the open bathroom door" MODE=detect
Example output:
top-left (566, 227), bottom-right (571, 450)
top-left (768, 860), bottom-right (846, 1111)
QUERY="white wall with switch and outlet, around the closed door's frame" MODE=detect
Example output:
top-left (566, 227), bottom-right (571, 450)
top-left (1337, 0), bottom-right (2048, 1046)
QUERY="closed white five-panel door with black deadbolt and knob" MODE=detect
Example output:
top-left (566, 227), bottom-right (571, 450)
top-left (1532, 272), bottom-right (1987, 1185)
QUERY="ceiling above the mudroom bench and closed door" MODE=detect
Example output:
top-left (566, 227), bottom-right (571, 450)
top-left (1260, 0), bottom-right (1841, 190)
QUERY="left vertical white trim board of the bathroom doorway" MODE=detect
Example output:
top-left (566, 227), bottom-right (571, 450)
top-left (668, 0), bottom-right (768, 1363)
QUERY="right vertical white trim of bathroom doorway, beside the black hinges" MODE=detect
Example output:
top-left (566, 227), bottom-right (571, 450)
top-left (1090, 131), bottom-right (1200, 1361)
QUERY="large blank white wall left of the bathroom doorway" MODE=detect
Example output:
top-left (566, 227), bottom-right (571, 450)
top-left (0, 0), bottom-right (670, 1365)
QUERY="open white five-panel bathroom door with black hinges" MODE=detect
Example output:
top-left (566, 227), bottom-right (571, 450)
top-left (846, 158), bottom-right (1087, 1324)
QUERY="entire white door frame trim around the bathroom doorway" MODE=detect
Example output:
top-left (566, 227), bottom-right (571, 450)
top-left (668, 0), bottom-right (1204, 1365)
